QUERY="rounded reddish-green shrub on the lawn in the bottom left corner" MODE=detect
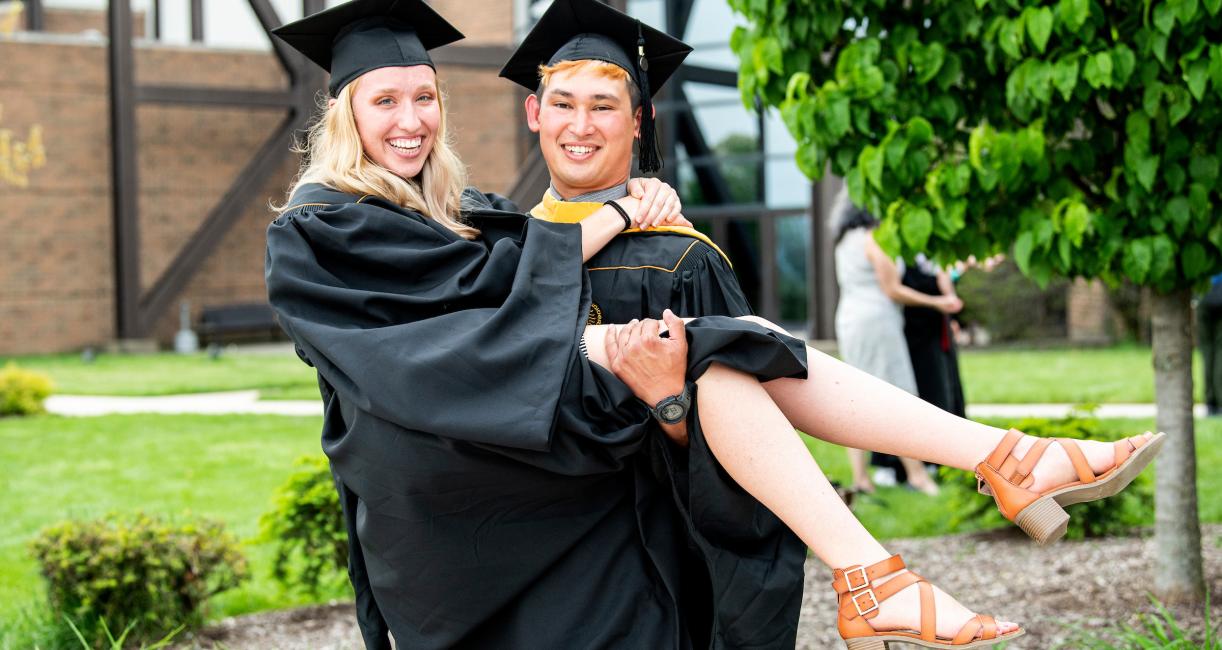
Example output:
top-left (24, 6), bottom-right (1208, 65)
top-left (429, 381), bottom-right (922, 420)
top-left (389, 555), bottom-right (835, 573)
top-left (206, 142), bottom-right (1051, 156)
top-left (31, 514), bottom-right (246, 644)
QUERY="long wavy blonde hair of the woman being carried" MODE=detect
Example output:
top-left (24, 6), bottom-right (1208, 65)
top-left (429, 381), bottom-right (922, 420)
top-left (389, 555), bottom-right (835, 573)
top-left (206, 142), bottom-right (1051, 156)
top-left (281, 78), bottom-right (479, 239)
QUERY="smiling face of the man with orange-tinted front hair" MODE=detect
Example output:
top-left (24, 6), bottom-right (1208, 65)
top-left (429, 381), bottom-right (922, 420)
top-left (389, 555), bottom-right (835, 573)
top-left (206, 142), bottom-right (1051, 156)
top-left (527, 61), bottom-right (640, 199)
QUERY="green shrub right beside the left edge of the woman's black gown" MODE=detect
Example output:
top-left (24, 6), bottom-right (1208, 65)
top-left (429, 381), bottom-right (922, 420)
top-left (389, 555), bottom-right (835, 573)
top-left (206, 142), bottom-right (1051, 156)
top-left (259, 456), bottom-right (348, 595)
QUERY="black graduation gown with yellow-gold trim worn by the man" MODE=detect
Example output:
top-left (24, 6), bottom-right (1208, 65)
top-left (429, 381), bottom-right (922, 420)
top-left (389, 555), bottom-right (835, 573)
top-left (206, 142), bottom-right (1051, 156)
top-left (525, 194), bottom-right (807, 648)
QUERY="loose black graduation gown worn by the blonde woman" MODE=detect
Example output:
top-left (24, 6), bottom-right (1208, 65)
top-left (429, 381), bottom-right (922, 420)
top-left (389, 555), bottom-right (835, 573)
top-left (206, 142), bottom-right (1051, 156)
top-left (266, 186), bottom-right (805, 649)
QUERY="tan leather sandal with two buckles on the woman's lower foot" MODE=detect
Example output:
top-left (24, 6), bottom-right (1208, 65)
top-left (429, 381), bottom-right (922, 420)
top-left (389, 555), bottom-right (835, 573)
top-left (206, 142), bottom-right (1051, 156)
top-left (832, 555), bottom-right (1024, 650)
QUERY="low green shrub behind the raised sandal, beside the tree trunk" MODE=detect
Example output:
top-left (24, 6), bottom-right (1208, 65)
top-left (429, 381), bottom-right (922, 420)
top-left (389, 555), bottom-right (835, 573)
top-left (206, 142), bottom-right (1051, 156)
top-left (940, 409), bottom-right (1154, 539)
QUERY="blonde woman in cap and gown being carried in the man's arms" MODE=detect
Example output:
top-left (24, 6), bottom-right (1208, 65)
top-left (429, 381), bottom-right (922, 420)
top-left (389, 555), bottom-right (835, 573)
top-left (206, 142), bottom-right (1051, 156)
top-left (266, 0), bottom-right (1161, 649)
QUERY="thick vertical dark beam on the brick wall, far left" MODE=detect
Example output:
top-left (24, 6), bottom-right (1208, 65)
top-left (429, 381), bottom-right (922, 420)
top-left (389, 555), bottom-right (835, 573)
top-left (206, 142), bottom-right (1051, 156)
top-left (106, 0), bottom-right (143, 340)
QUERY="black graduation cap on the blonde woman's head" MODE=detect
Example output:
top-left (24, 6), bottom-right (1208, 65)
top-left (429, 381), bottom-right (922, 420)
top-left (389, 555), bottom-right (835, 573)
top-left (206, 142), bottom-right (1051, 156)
top-left (271, 0), bottom-right (463, 97)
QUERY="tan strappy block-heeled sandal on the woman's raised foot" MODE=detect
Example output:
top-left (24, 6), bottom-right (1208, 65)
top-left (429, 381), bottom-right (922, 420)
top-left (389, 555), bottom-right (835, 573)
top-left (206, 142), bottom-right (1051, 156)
top-left (976, 429), bottom-right (1167, 546)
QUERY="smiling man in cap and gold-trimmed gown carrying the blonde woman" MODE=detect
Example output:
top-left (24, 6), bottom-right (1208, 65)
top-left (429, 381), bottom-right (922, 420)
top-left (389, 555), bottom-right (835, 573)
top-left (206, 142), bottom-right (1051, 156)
top-left (501, 0), bottom-right (805, 648)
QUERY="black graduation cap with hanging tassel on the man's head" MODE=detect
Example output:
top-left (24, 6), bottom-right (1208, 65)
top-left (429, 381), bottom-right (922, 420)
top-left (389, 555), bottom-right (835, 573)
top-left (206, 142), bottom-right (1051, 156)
top-left (501, 0), bottom-right (692, 172)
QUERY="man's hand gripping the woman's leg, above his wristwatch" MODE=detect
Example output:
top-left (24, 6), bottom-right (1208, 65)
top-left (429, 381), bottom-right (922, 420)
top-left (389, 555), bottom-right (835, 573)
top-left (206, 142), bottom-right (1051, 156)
top-left (606, 309), bottom-right (688, 446)
